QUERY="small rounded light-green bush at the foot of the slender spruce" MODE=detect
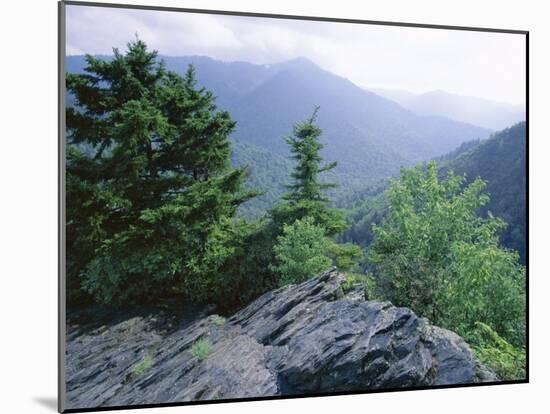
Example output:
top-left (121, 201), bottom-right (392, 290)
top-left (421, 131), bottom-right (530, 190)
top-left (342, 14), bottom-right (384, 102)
top-left (272, 217), bottom-right (332, 285)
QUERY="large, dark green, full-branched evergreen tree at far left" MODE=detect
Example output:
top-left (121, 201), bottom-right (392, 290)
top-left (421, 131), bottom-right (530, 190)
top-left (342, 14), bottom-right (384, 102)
top-left (66, 40), bottom-right (254, 304)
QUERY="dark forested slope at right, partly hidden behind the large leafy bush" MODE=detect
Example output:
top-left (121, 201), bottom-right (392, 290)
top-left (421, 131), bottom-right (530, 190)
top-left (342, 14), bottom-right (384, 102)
top-left (342, 122), bottom-right (526, 263)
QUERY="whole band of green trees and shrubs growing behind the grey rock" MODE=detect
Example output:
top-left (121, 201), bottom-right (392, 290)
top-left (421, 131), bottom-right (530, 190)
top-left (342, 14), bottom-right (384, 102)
top-left (66, 40), bottom-right (525, 379)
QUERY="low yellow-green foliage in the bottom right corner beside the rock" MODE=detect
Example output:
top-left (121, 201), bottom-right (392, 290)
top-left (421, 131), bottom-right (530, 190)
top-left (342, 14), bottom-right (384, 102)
top-left (464, 322), bottom-right (526, 380)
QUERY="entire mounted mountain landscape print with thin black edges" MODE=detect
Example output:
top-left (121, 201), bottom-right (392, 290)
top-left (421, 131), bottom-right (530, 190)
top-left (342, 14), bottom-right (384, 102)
top-left (59, 1), bottom-right (529, 412)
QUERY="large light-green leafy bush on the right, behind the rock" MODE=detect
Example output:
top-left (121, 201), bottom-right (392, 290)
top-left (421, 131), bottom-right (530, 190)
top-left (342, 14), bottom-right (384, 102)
top-left (369, 162), bottom-right (525, 346)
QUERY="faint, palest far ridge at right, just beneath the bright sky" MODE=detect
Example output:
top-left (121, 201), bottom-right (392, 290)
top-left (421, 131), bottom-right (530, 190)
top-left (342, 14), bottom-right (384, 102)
top-left (367, 88), bottom-right (525, 131)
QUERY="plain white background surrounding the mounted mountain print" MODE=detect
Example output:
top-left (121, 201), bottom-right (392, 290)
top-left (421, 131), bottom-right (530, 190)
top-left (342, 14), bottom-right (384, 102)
top-left (0, 0), bottom-right (550, 414)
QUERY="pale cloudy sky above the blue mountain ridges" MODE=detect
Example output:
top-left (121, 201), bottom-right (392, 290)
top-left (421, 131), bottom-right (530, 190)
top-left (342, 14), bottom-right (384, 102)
top-left (66, 5), bottom-right (526, 104)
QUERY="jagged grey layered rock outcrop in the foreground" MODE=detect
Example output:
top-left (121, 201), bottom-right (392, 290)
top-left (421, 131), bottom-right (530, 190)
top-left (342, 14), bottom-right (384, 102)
top-left (67, 270), bottom-right (496, 408)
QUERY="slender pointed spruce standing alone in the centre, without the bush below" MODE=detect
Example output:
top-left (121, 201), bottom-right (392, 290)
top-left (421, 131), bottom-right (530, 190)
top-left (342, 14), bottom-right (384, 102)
top-left (271, 107), bottom-right (346, 236)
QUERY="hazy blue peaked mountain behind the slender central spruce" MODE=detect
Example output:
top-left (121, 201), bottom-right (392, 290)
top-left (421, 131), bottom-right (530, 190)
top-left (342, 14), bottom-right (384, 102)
top-left (67, 56), bottom-right (498, 218)
